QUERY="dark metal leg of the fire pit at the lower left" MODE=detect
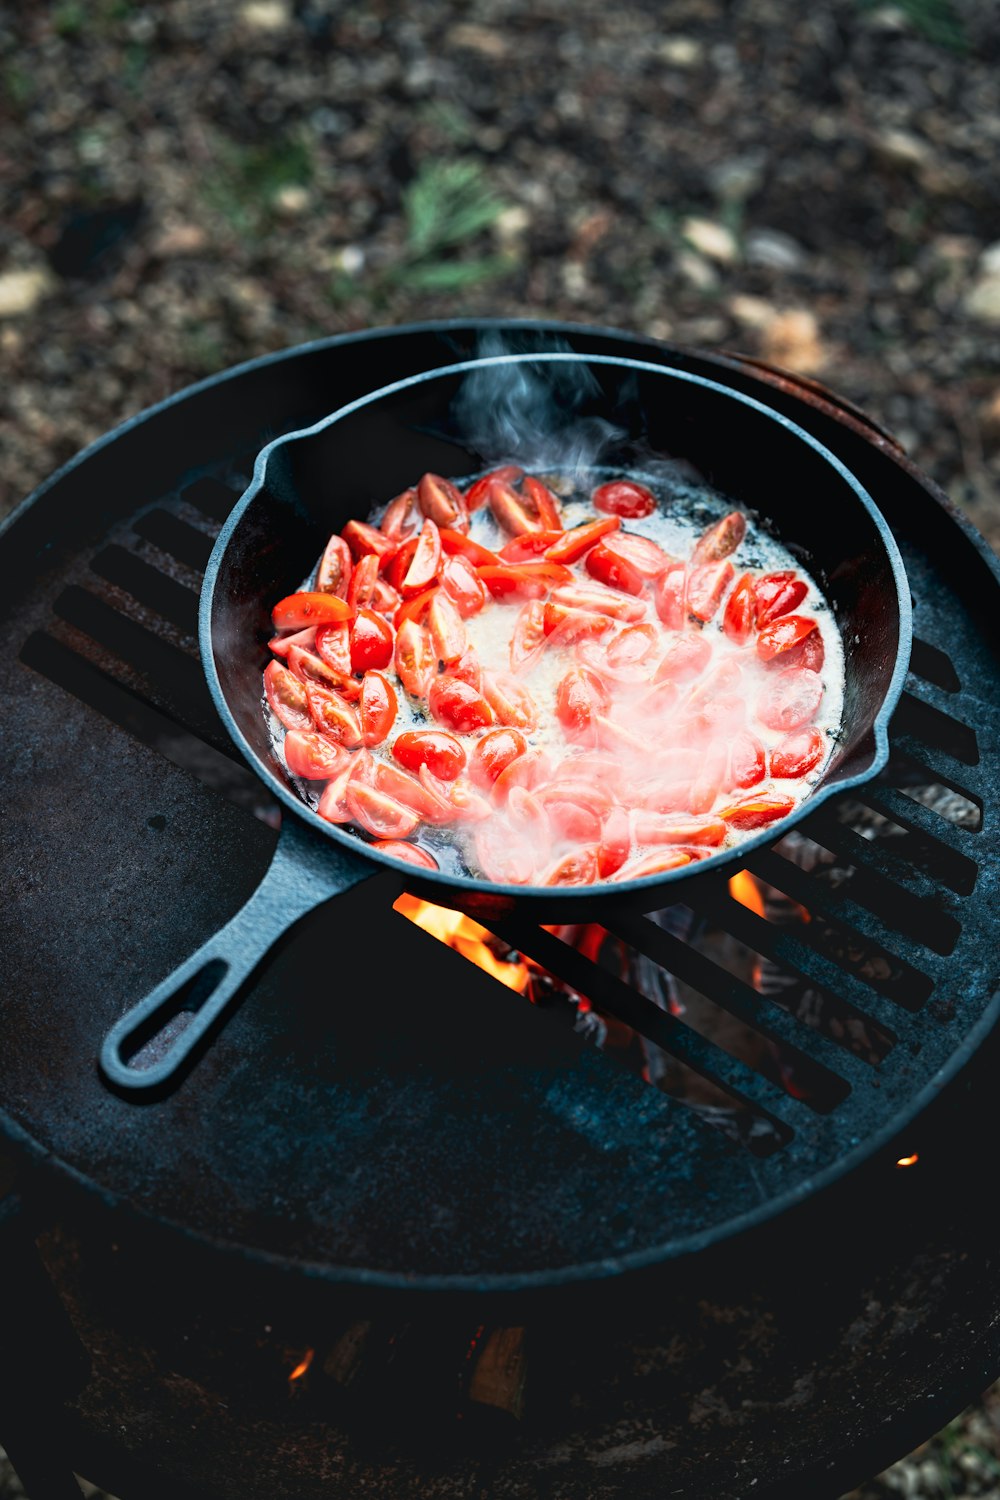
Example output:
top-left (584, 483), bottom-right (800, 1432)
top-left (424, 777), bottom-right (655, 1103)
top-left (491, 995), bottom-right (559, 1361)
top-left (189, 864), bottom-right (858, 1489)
top-left (0, 1182), bottom-right (84, 1500)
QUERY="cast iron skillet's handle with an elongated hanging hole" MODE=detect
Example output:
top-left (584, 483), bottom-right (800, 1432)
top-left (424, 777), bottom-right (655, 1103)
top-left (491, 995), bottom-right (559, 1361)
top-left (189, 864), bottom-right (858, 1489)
top-left (100, 818), bottom-right (375, 1098)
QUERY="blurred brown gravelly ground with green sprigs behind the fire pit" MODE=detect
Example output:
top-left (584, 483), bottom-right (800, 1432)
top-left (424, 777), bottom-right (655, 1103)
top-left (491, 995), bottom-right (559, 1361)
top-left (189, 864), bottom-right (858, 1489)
top-left (0, 0), bottom-right (1000, 1500)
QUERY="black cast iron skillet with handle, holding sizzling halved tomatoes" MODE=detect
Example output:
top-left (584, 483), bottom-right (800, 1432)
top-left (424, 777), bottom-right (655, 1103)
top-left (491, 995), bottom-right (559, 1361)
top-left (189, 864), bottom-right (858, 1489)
top-left (100, 354), bottom-right (912, 1092)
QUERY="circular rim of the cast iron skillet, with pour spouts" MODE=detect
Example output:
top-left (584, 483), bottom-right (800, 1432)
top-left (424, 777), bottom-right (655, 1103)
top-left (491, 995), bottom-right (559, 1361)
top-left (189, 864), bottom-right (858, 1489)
top-left (198, 353), bottom-right (913, 900)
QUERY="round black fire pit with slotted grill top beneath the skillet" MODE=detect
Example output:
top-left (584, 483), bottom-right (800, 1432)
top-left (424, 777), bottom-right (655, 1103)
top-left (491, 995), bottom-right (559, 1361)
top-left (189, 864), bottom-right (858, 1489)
top-left (0, 326), bottom-right (1000, 1500)
